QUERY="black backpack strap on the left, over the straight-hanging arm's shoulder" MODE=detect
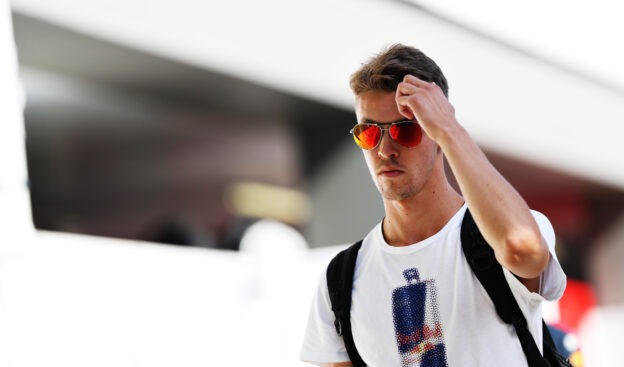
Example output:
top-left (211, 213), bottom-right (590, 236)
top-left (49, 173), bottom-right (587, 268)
top-left (326, 241), bottom-right (366, 367)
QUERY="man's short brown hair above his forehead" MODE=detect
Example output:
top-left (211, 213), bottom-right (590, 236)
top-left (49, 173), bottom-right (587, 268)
top-left (350, 44), bottom-right (448, 97)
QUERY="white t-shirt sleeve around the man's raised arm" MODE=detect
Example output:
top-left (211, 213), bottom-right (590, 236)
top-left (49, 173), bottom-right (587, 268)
top-left (505, 211), bottom-right (566, 302)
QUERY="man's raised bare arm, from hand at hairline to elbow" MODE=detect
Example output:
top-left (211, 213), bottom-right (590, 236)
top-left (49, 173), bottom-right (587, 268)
top-left (396, 75), bottom-right (550, 291)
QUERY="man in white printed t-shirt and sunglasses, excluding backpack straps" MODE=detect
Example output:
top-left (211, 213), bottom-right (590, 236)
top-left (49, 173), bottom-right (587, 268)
top-left (301, 45), bottom-right (565, 367)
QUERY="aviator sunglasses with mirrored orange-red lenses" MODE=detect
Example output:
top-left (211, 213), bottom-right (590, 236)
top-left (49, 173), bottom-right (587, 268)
top-left (350, 120), bottom-right (422, 150)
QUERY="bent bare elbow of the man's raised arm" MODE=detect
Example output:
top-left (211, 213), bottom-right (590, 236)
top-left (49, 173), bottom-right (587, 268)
top-left (499, 229), bottom-right (550, 279)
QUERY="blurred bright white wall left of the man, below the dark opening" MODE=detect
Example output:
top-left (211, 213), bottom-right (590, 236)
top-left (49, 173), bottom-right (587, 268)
top-left (0, 0), bottom-right (338, 367)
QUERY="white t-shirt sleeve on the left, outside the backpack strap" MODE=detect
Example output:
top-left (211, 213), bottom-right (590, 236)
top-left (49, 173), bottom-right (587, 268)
top-left (299, 272), bottom-right (349, 363)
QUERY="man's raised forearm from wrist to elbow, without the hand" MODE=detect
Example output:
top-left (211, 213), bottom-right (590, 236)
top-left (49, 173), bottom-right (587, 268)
top-left (437, 123), bottom-right (548, 278)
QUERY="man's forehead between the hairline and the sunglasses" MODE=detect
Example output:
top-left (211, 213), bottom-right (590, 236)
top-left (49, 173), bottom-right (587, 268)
top-left (355, 91), bottom-right (402, 122)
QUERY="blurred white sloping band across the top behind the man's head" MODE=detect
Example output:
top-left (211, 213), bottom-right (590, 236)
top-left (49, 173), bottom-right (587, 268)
top-left (11, 0), bottom-right (624, 193)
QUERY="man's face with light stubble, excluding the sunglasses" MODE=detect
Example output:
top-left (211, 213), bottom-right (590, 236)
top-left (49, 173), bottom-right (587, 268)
top-left (355, 91), bottom-right (442, 200)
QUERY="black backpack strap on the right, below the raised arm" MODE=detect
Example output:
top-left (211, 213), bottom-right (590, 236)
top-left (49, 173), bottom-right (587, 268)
top-left (461, 209), bottom-right (554, 367)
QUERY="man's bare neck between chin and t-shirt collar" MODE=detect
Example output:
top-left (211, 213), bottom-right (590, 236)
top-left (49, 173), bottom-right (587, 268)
top-left (382, 183), bottom-right (464, 246)
